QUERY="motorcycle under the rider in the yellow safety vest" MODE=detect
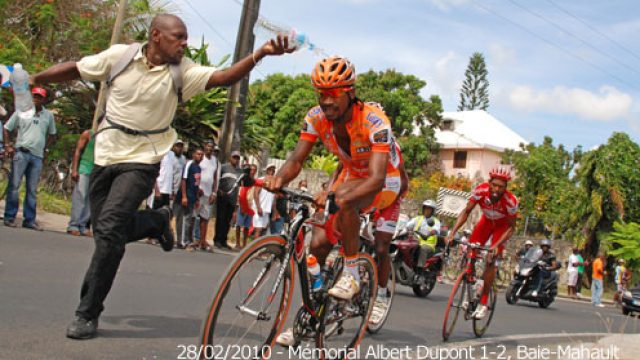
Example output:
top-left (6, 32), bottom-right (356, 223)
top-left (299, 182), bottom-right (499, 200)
top-left (389, 219), bottom-right (446, 297)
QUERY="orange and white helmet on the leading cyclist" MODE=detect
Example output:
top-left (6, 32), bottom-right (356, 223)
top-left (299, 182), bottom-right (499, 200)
top-left (311, 55), bottom-right (356, 89)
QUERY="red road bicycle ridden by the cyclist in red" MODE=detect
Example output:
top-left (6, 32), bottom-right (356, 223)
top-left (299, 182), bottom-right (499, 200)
top-left (442, 240), bottom-right (497, 341)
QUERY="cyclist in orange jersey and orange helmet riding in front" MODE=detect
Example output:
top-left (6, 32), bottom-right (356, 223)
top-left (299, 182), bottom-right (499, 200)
top-left (266, 56), bottom-right (402, 345)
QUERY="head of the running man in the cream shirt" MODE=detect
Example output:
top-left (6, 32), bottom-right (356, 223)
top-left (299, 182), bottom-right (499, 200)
top-left (149, 14), bottom-right (188, 65)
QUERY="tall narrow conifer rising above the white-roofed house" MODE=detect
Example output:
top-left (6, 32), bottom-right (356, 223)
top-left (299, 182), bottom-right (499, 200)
top-left (458, 52), bottom-right (489, 111)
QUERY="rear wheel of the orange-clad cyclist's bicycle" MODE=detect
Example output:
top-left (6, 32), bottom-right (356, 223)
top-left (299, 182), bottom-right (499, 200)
top-left (316, 253), bottom-right (378, 360)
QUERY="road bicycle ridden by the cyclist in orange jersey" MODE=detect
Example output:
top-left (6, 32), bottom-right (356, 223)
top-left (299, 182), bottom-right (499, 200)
top-left (198, 188), bottom-right (378, 360)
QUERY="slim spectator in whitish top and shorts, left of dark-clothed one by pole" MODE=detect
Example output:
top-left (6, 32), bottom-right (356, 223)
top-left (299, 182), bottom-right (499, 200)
top-left (198, 140), bottom-right (219, 250)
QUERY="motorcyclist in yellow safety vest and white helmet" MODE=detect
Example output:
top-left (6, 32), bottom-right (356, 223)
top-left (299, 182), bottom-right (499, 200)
top-left (407, 199), bottom-right (440, 269)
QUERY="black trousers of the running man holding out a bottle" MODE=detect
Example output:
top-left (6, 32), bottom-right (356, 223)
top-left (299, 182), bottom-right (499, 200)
top-left (76, 163), bottom-right (167, 319)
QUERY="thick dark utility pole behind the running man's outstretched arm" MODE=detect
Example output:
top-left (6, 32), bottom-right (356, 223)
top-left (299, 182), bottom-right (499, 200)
top-left (219, 0), bottom-right (260, 161)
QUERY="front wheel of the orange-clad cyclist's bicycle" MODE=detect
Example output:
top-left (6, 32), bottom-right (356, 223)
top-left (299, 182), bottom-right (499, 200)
top-left (200, 236), bottom-right (294, 359)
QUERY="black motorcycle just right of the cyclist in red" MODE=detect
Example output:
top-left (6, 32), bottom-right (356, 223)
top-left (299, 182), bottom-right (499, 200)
top-left (505, 248), bottom-right (558, 309)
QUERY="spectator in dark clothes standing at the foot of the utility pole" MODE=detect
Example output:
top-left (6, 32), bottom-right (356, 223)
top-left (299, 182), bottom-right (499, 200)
top-left (213, 151), bottom-right (242, 250)
